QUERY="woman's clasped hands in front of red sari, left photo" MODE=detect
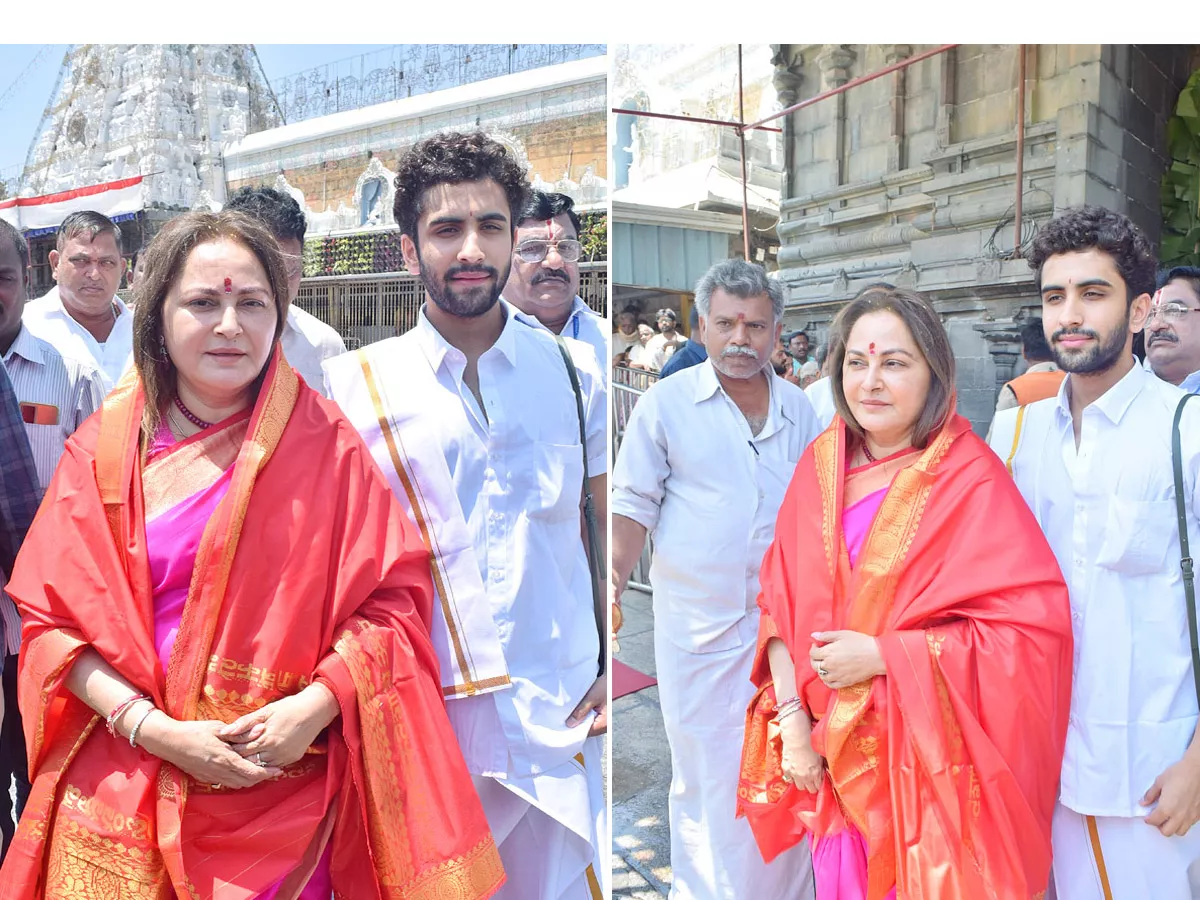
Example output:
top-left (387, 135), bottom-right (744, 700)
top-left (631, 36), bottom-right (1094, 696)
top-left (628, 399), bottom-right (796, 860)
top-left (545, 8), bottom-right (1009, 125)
top-left (139, 683), bottom-right (338, 788)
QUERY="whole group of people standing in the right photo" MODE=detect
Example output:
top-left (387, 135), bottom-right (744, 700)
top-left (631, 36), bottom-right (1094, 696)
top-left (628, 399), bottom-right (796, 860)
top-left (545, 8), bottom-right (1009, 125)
top-left (610, 206), bottom-right (1200, 900)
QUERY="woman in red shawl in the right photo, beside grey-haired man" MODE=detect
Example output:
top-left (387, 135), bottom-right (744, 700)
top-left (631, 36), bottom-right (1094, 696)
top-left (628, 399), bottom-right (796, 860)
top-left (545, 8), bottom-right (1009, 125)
top-left (738, 288), bottom-right (1072, 900)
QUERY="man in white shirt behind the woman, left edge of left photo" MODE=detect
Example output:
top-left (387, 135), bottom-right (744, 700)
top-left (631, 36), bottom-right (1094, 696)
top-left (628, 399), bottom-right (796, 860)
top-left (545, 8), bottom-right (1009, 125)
top-left (22, 210), bottom-right (133, 392)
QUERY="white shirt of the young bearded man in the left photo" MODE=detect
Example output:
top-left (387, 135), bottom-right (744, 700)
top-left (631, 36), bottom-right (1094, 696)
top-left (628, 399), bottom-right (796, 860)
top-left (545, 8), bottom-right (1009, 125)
top-left (416, 300), bottom-right (608, 776)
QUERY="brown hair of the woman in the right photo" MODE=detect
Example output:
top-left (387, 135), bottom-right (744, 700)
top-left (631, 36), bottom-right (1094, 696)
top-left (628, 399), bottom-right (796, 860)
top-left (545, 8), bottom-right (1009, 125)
top-left (829, 287), bottom-right (954, 448)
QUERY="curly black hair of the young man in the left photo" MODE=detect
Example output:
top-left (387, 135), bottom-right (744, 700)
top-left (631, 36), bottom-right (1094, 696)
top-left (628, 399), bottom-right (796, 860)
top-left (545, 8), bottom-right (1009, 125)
top-left (392, 131), bottom-right (529, 244)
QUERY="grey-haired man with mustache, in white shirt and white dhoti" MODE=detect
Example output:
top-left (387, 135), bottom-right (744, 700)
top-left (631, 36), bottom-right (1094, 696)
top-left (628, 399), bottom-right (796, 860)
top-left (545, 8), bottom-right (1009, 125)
top-left (611, 259), bottom-right (821, 900)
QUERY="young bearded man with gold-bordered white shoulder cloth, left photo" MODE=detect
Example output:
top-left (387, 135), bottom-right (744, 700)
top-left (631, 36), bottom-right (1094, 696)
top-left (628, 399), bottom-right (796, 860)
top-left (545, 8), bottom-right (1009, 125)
top-left (324, 133), bottom-right (608, 900)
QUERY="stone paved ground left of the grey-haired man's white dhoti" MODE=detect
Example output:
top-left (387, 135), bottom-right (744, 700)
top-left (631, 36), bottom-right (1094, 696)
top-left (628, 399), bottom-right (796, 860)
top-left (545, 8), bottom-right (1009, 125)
top-left (611, 589), bottom-right (671, 900)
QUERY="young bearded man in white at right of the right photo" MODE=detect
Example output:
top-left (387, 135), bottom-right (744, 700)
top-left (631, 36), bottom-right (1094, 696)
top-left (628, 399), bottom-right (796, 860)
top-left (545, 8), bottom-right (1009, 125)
top-left (984, 206), bottom-right (1200, 900)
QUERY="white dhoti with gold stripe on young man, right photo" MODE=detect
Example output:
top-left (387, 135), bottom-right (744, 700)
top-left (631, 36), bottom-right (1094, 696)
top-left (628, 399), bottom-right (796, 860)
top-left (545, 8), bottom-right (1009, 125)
top-left (1051, 803), bottom-right (1200, 900)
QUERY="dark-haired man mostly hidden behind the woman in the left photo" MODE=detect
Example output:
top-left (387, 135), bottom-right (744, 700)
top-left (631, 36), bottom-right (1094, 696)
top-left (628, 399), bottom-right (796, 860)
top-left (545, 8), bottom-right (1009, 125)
top-left (226, 187), bottom-right (346, 397)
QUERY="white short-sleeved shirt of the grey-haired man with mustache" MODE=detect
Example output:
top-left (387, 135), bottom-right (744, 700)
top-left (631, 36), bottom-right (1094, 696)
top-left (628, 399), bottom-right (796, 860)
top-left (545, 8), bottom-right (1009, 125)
top-left (610, 360), bottom-right (821, 653)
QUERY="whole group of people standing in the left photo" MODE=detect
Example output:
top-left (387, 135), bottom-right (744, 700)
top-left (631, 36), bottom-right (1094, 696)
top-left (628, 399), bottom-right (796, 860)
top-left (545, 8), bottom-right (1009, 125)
top-left (0, 133), bottom-right (610, 900)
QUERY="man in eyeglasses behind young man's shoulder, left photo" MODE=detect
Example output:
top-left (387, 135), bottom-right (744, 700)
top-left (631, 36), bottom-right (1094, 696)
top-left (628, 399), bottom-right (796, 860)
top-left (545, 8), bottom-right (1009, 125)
top-left (503, 191), bottom-right (608, 369)
